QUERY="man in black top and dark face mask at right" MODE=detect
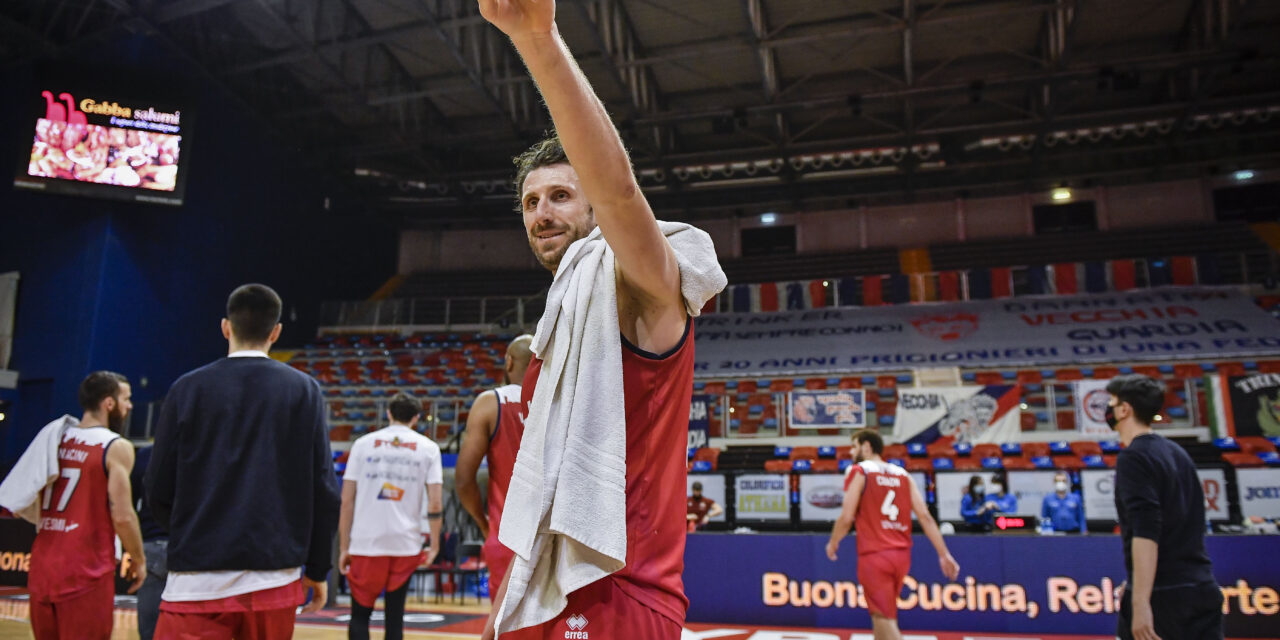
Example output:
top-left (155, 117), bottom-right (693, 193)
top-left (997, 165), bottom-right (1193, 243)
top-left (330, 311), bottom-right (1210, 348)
top-left (1106, 375), bottom-right (1222, 640)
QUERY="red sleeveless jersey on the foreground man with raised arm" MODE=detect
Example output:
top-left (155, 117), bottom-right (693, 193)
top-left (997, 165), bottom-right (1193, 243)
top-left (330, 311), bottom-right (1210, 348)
top-left (522, 320), bottom-right (694, 623)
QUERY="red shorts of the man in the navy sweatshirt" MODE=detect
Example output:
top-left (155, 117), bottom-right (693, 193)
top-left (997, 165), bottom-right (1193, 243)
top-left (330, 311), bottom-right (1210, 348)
top-left (155, 580), bottom-right (303, 640)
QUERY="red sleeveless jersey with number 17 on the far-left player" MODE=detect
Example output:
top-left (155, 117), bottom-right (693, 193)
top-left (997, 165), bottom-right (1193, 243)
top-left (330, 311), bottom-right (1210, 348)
top-left (27, 426), bottom-right (119, 602)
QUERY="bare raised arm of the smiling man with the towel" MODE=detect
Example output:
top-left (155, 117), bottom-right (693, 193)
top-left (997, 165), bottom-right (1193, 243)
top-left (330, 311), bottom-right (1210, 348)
top-left (479, 0), bottom-right (682, 308)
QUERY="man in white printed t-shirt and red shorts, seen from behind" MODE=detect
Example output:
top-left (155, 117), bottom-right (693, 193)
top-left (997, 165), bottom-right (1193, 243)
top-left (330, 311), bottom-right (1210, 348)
top-left (338, 393), bottom-right (444, 640)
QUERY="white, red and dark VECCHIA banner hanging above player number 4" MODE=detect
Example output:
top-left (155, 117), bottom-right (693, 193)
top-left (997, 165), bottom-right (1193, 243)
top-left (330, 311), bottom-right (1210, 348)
top-left (893, 385), bottom-right (1021, 444)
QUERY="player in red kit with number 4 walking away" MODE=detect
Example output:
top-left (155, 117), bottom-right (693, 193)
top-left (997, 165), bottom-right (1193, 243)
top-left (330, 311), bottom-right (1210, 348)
top-left (827, 429), bottom-right (960, 640)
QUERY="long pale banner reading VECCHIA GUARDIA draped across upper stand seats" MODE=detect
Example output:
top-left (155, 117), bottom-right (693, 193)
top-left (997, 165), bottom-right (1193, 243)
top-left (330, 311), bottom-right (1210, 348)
top-left (694, 287), bottom-right (1280, 376)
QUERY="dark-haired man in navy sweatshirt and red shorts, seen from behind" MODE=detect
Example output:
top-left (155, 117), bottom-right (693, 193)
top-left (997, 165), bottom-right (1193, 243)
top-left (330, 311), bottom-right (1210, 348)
top-left (146, 284), bottom-right (340, 639)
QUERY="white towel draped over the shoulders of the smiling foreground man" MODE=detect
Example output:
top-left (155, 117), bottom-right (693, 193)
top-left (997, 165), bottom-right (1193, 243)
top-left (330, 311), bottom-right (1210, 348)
top-left (497, 221), bottom-right (726, 635)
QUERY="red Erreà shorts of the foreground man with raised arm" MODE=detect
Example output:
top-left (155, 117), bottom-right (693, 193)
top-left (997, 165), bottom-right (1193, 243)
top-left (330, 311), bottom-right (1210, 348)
top-left (500, 577), bottom-right (681, 640)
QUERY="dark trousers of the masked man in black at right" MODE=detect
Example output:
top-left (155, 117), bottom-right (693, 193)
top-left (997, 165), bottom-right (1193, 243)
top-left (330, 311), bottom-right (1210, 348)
top-left (1116, 584), bottom-right (1222, 640)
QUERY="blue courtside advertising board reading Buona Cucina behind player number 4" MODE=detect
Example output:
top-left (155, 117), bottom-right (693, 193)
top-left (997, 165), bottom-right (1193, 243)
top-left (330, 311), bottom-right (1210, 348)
top-left (684, 534), bottom-right (1280, 637)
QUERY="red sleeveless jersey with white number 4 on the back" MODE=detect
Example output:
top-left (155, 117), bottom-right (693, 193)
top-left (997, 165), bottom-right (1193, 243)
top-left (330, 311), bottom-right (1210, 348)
top-left (845, 460), bottom-right (911, 556)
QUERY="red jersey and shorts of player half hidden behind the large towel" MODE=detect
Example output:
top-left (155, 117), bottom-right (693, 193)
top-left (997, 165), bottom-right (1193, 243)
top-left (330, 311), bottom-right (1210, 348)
top-left (484, 384), bottom-right (529, 583)
